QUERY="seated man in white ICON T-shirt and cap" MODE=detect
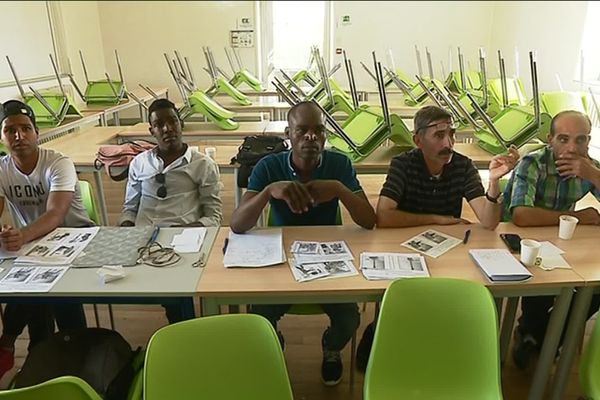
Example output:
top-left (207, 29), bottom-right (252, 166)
top-left (0, 100), bottom-right (93, 376)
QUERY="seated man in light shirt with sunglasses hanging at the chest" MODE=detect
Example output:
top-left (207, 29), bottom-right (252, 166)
top-left (120, 99), bottom-right (223, 323)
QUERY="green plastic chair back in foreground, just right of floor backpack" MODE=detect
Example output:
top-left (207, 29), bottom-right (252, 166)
top-left (143, 314), bottom-right (293, 400)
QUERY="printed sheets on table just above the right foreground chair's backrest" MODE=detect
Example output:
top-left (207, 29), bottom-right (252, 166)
top-left (360, 253), bottom-right (429, 280)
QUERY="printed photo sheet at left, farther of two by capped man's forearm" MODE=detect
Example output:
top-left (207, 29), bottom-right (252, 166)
top-left (15, 227), bottom-right (99, 265)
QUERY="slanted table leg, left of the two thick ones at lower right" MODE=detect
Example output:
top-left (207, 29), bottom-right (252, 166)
top-left (528, 287), bottom-right (573, 400)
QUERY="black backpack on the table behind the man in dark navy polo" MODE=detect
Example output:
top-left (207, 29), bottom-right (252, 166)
top-left (231, 135), bottom-right (288, 188)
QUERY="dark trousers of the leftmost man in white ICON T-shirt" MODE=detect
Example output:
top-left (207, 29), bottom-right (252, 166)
top-left (3, 304), bottom-right (87, 349)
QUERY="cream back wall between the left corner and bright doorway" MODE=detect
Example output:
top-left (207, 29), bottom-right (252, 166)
top-left (98, 1), bottom-right (256, 100)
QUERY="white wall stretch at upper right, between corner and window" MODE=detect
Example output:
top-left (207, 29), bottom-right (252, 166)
top-left (489, 1), bottom-right (588, 92)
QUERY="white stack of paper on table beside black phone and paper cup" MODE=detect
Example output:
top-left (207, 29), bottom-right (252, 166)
top-left (469, 249), bottom-right (532, 282)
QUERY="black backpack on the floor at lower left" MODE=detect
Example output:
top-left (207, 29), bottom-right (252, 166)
top-left (14, 328), bottom-right (141, 400)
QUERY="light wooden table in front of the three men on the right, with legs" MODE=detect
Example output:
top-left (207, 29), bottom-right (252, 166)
top-left (197, 224), bottom-right (600, 399)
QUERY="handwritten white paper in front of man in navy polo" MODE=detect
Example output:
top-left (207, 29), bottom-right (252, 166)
top-left (223, 229), bottom-right (285, 267)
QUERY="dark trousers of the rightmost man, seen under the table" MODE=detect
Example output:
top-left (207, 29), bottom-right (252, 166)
top-left (517, 295), bottom-right (600, 347)
